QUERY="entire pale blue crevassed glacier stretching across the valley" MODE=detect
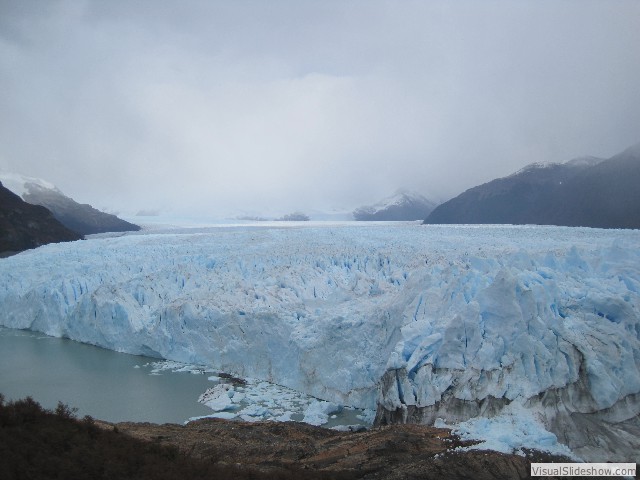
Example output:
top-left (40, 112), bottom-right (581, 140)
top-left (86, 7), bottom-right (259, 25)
top-left (0, 222), bottom-right (640, 461)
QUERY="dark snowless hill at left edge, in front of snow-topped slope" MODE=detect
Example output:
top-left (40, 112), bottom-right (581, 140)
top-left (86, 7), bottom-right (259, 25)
top-left (0, 182), bottom-right (82, 257)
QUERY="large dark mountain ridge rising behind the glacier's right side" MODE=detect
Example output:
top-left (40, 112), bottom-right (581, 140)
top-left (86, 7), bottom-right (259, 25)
top-left (424, 144), bottom-right (640, 228)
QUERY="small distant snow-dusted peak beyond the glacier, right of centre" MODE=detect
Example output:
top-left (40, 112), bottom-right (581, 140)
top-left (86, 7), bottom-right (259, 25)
top-left (353, 190), bottom-right (436, 221)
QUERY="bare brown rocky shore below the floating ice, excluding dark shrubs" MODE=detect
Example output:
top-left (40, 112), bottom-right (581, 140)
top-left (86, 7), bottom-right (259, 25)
top-left (96, 419), bottom-right (569, 479)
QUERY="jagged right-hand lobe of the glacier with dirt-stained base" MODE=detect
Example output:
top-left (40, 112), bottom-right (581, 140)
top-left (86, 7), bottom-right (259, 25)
top-left (376, 241), bottom-right (640, 461)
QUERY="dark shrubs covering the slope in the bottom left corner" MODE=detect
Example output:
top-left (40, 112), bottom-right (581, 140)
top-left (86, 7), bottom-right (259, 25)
top-left (0, 395), bottom-right (356, 480)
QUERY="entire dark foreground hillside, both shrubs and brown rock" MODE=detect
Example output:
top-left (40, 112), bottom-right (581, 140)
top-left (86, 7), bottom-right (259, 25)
top-left (0, 395), bottom-right (567, 480)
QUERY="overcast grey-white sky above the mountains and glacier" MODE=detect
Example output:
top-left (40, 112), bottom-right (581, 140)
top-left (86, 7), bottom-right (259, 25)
top-left (0, 0), bottom-right (640, 214)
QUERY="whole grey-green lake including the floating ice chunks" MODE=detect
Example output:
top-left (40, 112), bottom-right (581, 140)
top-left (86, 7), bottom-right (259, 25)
top-left (0, 327), bottom-right (375, 427)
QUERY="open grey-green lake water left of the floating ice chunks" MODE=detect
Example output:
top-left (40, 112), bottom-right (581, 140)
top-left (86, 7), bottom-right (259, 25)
top-left (0, 327), bottom-right (212, 423)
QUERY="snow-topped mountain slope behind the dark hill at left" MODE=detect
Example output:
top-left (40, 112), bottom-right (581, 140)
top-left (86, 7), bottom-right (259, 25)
top-left (0, 173), bottom-right (140, 235)
